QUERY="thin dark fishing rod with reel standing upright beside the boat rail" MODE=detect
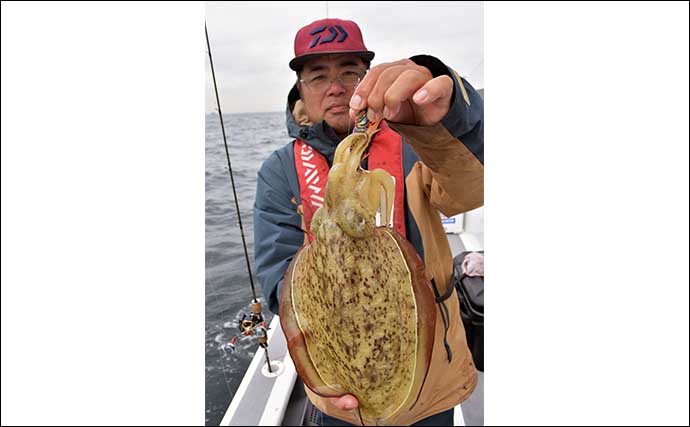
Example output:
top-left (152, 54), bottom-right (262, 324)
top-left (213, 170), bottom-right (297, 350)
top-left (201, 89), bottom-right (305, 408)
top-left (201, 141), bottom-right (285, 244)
top-left (204, 23), bottom-right (273, 373)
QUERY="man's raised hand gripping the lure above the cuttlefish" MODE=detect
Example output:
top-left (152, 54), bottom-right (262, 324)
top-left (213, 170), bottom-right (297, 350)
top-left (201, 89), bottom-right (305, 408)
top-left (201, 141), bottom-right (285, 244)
top-left (350, 59), bottom-right (453, 126)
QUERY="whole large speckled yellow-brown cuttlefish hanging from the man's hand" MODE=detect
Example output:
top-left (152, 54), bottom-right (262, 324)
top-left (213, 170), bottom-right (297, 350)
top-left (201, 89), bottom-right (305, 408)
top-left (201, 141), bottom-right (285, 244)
top-left (280, 115), bottom-right (436, 425)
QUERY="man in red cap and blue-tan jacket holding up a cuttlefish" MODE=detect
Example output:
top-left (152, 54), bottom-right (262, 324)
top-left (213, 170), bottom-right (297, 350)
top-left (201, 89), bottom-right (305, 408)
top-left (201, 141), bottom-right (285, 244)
top-left (254, 19), bottom-right (484, 425)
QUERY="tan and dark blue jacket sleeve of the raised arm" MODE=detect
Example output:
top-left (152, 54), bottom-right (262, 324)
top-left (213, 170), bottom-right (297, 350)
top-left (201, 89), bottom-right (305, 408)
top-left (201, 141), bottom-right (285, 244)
top-left (390, 55), bottom-right (484, 216)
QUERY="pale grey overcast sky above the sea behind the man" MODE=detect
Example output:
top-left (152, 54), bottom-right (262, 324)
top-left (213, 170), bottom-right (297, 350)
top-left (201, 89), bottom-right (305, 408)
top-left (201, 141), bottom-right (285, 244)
top-left (204, 1), bottom-right (484, 113)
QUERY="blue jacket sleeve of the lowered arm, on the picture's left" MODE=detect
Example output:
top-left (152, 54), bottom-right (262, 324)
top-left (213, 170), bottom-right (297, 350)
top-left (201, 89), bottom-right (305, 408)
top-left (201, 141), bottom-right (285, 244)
top-left (253, 153), bottom-right (304, 314)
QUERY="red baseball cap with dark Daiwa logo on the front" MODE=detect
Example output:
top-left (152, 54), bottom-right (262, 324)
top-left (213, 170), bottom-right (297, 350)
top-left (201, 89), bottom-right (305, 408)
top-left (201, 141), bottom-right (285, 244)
top-left (290, 19), bottom-right (374, 71)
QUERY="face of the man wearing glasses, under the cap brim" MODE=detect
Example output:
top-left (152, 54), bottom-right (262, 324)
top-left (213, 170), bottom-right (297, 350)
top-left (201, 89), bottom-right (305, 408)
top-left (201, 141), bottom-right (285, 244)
top-left (298, 54), bottom-right (366, 135)
